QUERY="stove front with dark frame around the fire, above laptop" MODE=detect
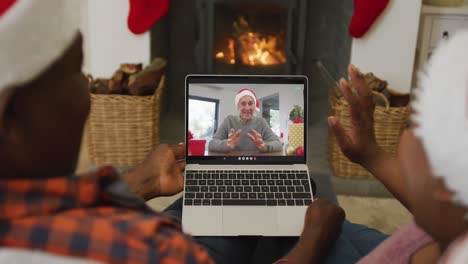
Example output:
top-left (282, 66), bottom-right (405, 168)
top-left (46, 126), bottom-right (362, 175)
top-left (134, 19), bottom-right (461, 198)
top-left (195, 0), bottom-right (307, 74)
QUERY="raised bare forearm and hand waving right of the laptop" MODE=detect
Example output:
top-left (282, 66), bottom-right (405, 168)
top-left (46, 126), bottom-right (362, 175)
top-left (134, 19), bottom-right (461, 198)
top-left (328, 65), bottom-right (408, 208)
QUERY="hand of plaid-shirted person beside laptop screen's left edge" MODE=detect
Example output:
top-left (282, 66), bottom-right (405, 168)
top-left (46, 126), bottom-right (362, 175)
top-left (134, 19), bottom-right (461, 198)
top-left (123, 143), bottom-right (185, 200)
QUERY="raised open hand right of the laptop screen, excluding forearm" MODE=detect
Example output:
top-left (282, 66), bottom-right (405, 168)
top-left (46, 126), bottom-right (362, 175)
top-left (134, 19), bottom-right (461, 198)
top-left (328, 65), bottom-right (379, 165)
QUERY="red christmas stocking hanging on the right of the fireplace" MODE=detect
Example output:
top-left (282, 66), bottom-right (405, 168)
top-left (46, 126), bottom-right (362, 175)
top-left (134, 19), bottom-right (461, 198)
top-left (349, 0), bottom-right (390, 38)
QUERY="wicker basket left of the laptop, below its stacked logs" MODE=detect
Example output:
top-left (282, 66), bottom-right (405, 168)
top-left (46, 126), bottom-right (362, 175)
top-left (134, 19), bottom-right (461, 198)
top-left (86, 76), bottom-right (165, 167)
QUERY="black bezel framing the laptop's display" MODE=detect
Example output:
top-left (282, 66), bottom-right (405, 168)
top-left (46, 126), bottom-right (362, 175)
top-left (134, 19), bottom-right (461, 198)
top-left (185, 74), bottom-right (309, 165)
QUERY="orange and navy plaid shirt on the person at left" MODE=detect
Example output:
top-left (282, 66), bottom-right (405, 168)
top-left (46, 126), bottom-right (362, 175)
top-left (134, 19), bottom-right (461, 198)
top-left (0, 167), bottom-right (212, 263)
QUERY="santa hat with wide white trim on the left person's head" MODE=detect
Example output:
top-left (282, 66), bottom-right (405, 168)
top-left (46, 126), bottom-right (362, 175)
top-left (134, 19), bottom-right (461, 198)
top-left (0, 0), bottom-right (81, 92)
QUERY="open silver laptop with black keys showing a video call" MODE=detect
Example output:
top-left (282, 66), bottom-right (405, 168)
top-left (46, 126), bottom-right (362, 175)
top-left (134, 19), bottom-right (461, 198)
top-left (182, 75), bottom-right (313, 236)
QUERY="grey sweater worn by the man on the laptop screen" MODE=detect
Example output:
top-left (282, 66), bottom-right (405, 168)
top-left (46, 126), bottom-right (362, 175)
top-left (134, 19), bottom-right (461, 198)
top-left (208, 115), bottom-right (282, 152)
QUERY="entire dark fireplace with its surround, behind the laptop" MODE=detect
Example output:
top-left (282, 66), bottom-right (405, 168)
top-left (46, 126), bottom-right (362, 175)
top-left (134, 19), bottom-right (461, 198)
top-left (151, 0), bottom-right (353, 128)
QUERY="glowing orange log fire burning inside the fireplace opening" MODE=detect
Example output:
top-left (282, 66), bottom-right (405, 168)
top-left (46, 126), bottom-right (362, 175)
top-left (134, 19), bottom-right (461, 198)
top-left (213, 4), bottom-right (287, 67)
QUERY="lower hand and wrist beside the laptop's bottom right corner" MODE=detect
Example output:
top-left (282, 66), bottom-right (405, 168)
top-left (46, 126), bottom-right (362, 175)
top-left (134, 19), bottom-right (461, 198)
top-left (286, 199), bottom-right (345, 263)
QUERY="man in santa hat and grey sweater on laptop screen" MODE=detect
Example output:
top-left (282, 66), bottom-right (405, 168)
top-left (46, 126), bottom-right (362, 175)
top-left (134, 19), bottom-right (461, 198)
top-left (208, 89), bottom-right (282, 152)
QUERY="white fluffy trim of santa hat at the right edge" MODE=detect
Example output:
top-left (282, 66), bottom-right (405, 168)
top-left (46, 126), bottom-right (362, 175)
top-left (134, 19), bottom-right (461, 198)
top-left (412, 31), bottom-right (468, 207)
